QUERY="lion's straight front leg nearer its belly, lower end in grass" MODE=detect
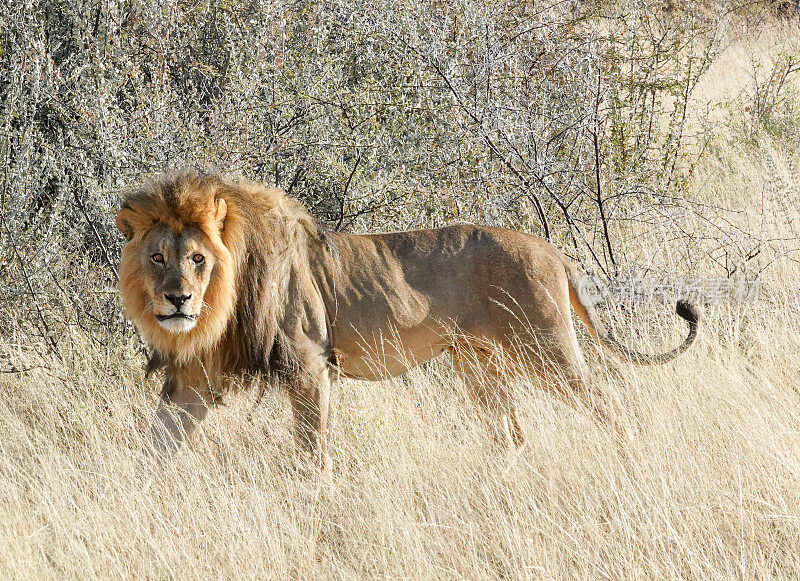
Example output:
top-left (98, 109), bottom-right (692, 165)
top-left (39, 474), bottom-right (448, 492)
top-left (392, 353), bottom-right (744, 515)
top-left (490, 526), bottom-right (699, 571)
top-left (289, 370), bottom-right (331, 475)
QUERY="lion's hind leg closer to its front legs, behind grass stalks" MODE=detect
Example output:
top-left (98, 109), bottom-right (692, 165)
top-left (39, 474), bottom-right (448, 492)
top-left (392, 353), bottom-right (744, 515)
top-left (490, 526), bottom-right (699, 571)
top-left (448, 344), bottom-right (525, 450)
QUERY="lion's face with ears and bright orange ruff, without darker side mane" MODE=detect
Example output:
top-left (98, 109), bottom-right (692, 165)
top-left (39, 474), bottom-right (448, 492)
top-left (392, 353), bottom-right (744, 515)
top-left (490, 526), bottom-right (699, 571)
top-left (117, 183), bottom-right (236, 360)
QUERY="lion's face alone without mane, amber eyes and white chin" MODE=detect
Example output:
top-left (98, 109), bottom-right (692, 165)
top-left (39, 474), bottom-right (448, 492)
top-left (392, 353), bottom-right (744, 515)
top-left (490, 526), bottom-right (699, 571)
top-left (136, 224), bottom-right (216, 333)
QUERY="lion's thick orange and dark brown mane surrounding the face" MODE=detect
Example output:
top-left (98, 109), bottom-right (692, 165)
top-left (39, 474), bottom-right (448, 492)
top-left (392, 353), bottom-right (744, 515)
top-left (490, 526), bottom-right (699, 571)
top-left (120, 170), bottom-right (326, 373)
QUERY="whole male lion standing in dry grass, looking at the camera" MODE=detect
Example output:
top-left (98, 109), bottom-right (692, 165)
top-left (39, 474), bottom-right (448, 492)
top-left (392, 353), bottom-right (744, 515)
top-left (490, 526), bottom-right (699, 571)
top-left (117, 170), bottom-right (699, 472)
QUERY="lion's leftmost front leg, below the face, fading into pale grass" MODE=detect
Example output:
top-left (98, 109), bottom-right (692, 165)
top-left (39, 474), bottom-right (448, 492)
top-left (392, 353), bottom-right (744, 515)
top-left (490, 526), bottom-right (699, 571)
top-left (150, 372), bottom-right (208, 457)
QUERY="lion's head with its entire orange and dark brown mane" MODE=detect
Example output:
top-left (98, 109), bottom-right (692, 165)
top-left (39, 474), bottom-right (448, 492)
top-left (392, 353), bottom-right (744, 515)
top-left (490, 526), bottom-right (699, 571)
top-left (117, 170), bottom-right (319, 360)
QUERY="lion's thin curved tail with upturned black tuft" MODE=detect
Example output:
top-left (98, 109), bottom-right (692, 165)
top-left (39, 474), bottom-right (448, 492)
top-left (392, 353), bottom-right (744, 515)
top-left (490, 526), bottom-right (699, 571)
top-left (564, 262), bottom-right (700, 365)
